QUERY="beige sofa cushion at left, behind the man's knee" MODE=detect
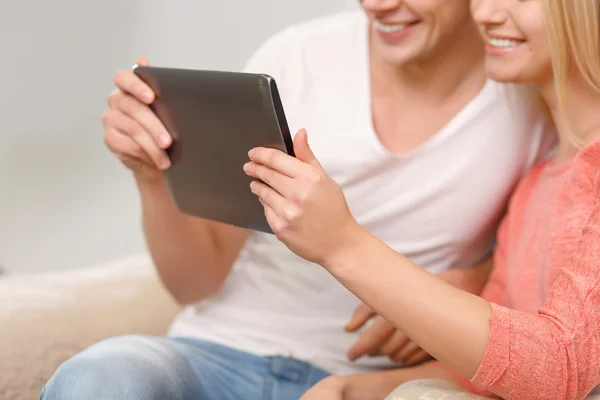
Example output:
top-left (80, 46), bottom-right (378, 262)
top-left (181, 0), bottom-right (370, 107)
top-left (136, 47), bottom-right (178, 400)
top-left (0, 255), bottom-right (179, 400)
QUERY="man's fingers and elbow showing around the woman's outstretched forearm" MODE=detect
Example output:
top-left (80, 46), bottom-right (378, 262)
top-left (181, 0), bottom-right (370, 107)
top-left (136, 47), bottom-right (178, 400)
top-left (345, 257), bottom-right (493, 366)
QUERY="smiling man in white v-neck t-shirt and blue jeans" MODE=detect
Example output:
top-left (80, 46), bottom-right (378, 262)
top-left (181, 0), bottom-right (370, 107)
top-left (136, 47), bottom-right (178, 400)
top-left (42, 0), bottom-right (545, 400)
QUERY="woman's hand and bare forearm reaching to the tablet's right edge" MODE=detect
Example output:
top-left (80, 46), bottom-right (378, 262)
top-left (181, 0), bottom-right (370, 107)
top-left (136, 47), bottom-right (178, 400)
top-left (244, 145), bottom-right (492, 376)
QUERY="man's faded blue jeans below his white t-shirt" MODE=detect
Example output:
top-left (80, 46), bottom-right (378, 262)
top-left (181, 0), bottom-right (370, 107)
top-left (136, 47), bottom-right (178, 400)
top-left (40, 336), bottom-right (328, 400)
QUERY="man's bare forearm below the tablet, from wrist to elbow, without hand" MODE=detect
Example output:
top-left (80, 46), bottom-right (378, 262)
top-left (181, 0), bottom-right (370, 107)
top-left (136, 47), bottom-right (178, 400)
top-left (136, 177), bottom-right (247, 304)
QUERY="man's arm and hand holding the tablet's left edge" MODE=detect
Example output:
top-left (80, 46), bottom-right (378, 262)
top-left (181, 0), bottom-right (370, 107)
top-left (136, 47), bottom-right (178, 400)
top-left (102, 57), bottom-right (255, 304)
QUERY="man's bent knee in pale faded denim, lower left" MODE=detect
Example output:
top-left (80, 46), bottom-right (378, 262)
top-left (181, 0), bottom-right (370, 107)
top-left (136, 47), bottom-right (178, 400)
top-left (41, 336), bottom-right (189, 400)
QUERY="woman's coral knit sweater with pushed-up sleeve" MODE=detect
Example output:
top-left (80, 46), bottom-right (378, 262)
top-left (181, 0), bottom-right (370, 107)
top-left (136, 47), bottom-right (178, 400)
top-left (462, 141), bottom-right (600, 399)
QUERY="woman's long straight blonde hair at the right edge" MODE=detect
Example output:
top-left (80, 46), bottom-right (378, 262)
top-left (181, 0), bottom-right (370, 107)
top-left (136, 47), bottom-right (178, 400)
top-left (544, 0), bottom-right (600, 147)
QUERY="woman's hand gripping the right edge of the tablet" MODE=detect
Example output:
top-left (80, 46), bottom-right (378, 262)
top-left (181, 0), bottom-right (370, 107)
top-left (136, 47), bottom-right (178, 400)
top-left (244, 130), bottom-right (366, 266)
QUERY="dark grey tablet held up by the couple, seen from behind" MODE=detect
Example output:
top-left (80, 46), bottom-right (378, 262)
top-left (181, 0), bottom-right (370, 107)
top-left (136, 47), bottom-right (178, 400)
top-left (134, 66), bottom-right (294, 233)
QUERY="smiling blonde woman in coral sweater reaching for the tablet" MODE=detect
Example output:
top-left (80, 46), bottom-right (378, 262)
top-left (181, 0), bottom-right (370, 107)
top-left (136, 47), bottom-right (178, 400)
top-left (244, 0), bottom-right (600, 399)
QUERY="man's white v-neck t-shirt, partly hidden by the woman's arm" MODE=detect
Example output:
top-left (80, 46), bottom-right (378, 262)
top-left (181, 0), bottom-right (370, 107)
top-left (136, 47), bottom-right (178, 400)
top-left (170, 12), bottom-right (550, 374)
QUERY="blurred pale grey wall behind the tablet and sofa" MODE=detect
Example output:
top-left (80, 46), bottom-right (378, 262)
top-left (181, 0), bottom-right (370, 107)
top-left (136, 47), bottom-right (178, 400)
top-left (0, 0), bottom-right (357, 272)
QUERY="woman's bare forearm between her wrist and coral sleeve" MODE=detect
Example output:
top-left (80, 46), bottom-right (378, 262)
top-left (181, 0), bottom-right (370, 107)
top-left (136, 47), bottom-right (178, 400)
top-left (323, 230), bottom-right (492, 377)
